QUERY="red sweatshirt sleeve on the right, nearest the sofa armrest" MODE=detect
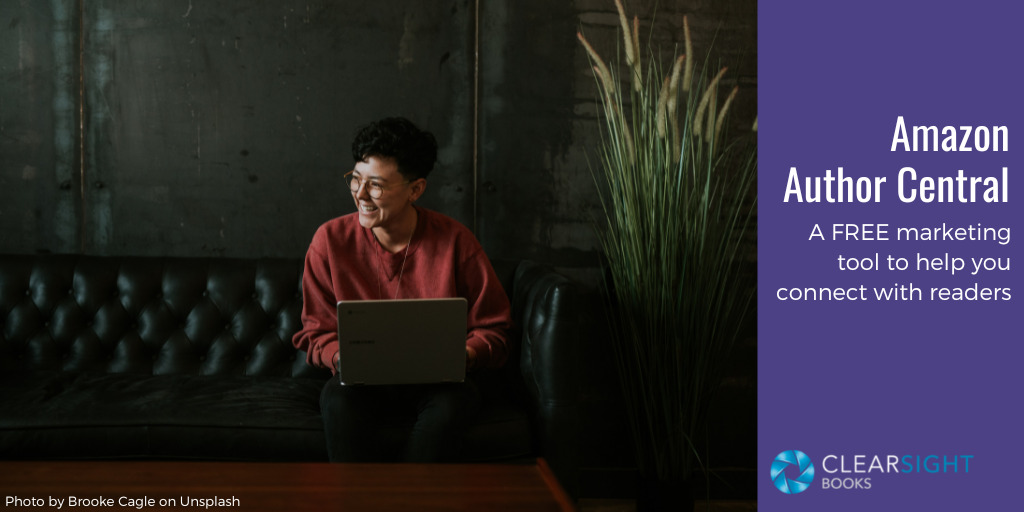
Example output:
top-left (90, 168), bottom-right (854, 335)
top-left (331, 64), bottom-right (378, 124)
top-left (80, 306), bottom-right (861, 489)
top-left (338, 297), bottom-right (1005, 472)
top-left (459, 247), bottom-right (512, 368)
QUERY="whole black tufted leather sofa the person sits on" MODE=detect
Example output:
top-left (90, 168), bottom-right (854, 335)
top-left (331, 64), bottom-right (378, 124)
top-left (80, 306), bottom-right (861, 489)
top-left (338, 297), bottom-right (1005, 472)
top-left (0, 255), bottom-right (583, 492)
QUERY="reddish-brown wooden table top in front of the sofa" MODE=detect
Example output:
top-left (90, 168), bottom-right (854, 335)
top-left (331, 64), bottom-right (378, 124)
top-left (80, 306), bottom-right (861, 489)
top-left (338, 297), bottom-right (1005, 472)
top-left (0, 460), bottom-right (574, 512)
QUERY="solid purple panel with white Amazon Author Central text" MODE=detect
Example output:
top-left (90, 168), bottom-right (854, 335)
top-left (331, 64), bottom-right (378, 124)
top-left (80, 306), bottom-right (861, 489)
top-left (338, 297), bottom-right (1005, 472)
top-left (758, 0), bottom-right (1024, 512)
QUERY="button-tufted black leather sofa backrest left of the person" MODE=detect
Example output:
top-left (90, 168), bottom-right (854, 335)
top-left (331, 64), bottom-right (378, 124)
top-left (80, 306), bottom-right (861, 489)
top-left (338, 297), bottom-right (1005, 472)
top-left (0, 255), bottom-right (326, 377)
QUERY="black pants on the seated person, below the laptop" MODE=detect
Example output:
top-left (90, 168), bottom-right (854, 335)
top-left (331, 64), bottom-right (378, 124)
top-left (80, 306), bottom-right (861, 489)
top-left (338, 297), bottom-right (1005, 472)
top-left (321, 375), bottom-right (480, 462)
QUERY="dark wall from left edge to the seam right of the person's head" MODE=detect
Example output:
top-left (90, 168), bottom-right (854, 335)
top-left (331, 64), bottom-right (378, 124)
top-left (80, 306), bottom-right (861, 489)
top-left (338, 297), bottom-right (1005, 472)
top-left (0, 0), bottom-right (474, 257)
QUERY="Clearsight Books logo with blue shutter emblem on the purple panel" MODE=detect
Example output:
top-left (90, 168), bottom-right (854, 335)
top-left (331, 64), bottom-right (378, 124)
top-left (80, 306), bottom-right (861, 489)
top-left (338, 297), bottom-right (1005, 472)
top-left (771, 450), bottom-right (974, 495)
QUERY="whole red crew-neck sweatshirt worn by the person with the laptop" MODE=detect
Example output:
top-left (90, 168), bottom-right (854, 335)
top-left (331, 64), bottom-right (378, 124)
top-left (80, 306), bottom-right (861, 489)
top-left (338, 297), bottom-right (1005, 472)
top-left (292, 207), bottom-right (512, 372)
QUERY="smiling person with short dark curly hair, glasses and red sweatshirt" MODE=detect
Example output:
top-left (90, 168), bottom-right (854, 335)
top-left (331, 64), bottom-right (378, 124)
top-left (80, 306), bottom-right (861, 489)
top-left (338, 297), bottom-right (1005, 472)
top-left (293, 118), bottom-right (511, 462)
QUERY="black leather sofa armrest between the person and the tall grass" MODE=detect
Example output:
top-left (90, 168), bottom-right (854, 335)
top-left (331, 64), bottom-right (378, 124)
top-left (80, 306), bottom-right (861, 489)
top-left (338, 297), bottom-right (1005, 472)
top-left (513, 261), bottom-right (585, 495)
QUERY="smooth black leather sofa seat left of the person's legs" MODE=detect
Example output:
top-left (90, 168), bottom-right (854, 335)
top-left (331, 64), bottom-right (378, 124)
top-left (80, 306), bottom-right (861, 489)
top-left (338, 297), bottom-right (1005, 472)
top-left (0, 373), bottom-right (325, 461)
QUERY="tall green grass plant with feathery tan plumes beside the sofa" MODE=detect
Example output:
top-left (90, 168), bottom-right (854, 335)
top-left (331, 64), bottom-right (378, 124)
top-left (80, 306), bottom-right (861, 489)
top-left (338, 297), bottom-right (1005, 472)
top-left (578, 0), bottom-right (757, 507)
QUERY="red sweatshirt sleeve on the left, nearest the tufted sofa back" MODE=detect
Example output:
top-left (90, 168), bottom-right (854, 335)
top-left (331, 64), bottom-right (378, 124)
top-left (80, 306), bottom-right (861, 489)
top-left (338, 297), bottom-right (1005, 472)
top-left (292, 228), bottom-right (338, 373)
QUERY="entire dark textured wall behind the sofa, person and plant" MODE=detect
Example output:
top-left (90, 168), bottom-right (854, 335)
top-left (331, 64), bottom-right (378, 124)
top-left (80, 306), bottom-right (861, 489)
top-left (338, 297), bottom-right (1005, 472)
top-left (0, 0), bottom-right (757, 492)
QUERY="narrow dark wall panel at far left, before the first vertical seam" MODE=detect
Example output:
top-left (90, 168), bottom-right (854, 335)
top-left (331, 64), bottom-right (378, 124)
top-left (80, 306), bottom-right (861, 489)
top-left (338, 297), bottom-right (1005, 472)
top-left (0, 0), bottom-right (82, 252)
